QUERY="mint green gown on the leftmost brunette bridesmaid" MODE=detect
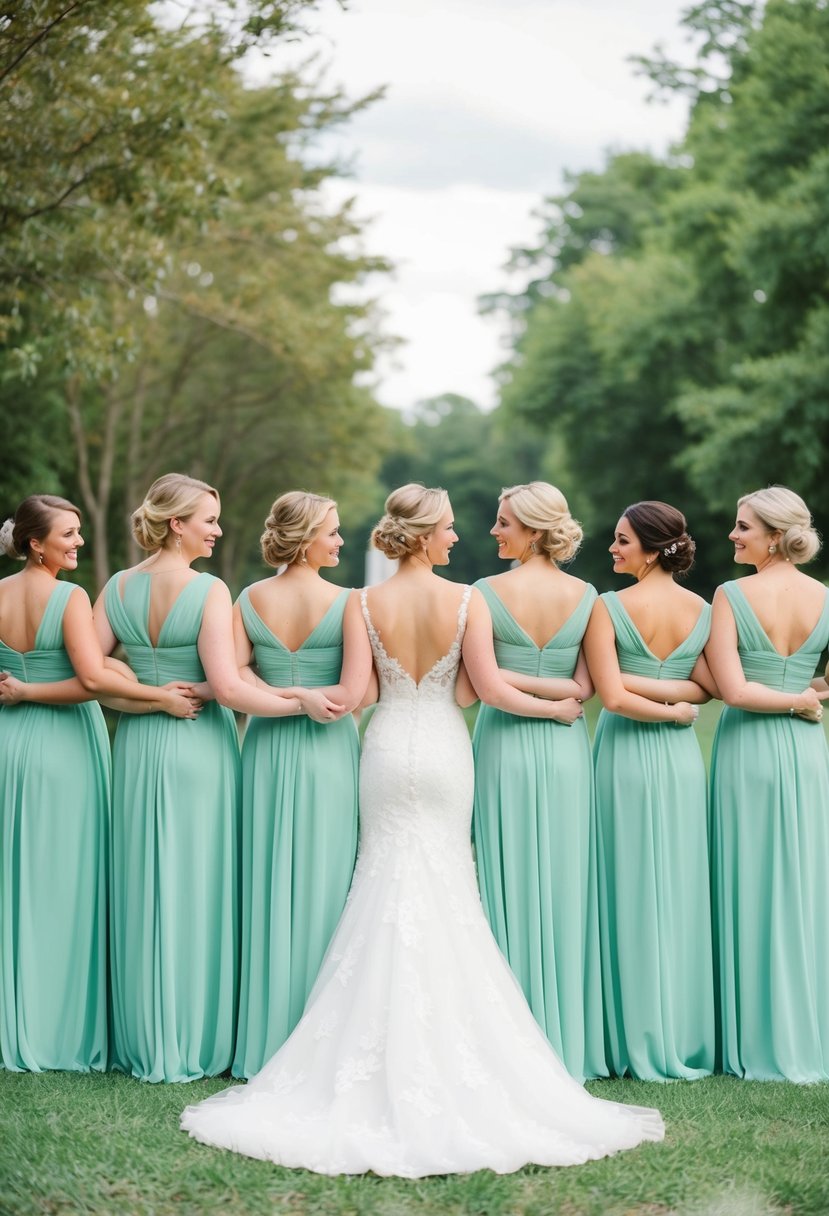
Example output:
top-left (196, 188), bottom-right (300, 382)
top-left (0, 582), bottom-right (109, 1073)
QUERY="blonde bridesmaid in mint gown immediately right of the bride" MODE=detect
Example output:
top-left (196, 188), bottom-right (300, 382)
top-left (473, 482), bottom-right (607, 1080)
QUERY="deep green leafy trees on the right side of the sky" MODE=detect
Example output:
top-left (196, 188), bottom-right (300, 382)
top-left (490, 0), bottom-right (829, 589)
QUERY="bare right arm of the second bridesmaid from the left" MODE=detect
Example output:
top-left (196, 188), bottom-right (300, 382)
top-left (198, 580), bottom-right (345, 722)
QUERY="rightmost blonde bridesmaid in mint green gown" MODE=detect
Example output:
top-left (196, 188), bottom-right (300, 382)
top-left (707, 485), bottom-right (829, 1081)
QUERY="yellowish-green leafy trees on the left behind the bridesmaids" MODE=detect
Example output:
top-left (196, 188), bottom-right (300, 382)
top-left (0, 0), bottom-right (387, 585)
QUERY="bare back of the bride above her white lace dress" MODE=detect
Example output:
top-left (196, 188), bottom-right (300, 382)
top-left (366, 570), bottom-right (464, 683)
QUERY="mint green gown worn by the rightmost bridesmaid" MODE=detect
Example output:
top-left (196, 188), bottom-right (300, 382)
top-left (711, 582), bottom-right (829, 1081)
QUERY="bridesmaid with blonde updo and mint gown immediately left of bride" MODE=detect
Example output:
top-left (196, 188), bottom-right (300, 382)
top-left (233, 490), bottom-right (360, 1077)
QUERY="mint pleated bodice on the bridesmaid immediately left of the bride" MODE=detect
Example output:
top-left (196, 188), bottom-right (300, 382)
top-left (239, 587), bottom-right (349, 688)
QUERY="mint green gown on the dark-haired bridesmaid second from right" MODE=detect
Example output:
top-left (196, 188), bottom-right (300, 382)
top-left (594, 591), bottom-right (715, 1081)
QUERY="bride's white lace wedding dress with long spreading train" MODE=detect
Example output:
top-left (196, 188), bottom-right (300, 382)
top-left (181, 590), bottom-right (664, 1178)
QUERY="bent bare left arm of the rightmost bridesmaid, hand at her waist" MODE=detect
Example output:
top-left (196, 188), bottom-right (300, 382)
top-left (705, 587), bottom-right (829, 721)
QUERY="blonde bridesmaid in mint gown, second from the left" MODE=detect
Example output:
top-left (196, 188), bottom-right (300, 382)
top-left (95, 473), bottom-right (339, 1081)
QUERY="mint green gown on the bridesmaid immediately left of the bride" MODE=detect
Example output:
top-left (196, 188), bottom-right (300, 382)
top-left (233, 589), bottom-right (360, 1077)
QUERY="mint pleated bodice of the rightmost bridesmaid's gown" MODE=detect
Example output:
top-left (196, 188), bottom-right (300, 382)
top-left (722, 581), bottom-right (829, 692)
